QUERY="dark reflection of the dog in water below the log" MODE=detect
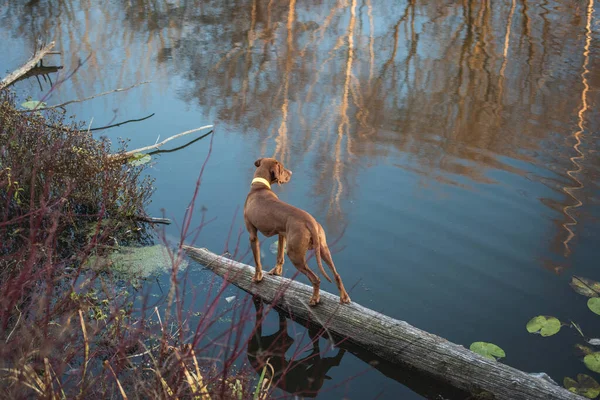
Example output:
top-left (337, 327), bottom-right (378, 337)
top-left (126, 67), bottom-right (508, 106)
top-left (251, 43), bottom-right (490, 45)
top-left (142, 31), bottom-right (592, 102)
top-left (248, 297), bottom-right (345, 397)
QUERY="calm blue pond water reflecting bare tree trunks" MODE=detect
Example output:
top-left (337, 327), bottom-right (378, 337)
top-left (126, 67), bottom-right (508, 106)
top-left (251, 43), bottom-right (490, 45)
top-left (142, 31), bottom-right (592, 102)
top-left (0, 0), bottom-right (600, 399)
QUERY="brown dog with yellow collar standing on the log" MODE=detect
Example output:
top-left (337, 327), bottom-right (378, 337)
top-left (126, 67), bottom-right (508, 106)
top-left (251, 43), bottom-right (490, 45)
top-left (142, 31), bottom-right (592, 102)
top-left (244, 158), bottom-right (350, 306)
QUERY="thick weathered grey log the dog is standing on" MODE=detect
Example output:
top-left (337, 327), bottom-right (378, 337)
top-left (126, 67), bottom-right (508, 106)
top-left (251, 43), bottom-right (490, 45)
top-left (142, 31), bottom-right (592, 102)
top-left (184, 246), bottom-right (583, 400)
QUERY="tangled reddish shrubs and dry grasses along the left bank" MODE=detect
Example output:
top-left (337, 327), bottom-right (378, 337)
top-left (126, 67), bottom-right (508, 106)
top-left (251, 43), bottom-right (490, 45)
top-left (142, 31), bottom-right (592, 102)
top-left (0, 47), bottom-right (264, 399)
